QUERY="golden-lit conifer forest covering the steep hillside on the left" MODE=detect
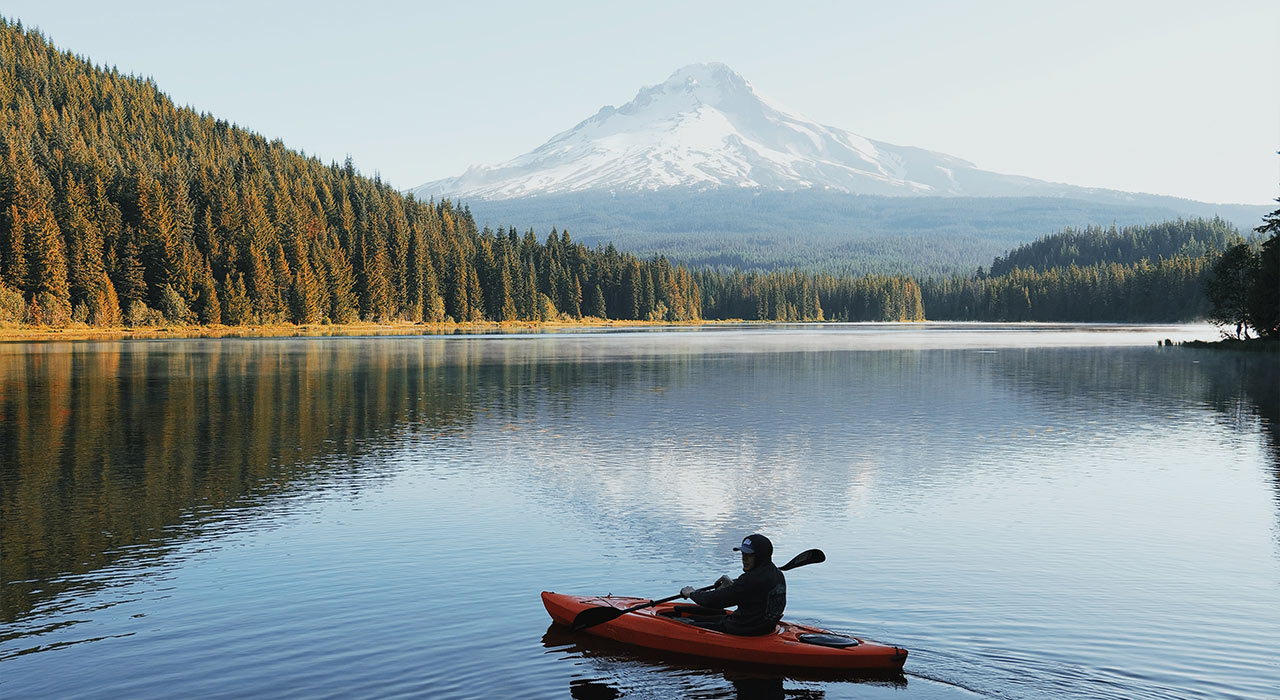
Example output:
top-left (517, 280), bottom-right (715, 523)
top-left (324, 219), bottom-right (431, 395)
top-left (0, 18), bottom-right (701, 325)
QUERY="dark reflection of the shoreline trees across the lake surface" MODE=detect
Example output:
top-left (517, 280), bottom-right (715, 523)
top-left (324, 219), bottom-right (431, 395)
top-left (0, 338), bottom-right (1280, 622)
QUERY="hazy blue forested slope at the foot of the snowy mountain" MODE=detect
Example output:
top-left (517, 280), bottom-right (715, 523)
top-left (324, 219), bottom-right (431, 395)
top-left (470, 189), bottom-right (1267, 278)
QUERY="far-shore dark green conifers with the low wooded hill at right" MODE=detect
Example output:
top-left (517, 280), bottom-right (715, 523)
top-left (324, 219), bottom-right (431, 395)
top-left (695, 219), bottom-right (1243, 322)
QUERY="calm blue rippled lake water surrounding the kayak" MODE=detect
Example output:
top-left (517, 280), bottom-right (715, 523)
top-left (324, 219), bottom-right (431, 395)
top-left (0, 324), bottom-right (1280, 700)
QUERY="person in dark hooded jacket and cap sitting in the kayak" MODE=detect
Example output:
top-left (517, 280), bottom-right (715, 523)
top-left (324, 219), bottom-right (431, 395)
top-left (680, 534), bottom-right (787, 636)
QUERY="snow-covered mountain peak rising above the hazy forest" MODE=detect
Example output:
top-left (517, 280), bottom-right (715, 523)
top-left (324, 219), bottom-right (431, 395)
top-left (412, 63), bottom-right (1079, 200)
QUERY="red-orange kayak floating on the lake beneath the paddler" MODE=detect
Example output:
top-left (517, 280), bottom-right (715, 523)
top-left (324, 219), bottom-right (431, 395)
top-left (543, 591), bottom-right (906, 673)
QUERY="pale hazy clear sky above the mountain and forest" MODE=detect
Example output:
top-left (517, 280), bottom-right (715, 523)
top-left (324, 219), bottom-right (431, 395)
top-left (0, 0), bottom-right (1280, 203)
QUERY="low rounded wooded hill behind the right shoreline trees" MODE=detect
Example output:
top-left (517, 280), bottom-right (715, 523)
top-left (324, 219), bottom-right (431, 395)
top-left (991, 216), bottom-right (1240, 276)
